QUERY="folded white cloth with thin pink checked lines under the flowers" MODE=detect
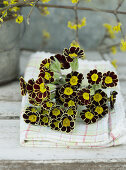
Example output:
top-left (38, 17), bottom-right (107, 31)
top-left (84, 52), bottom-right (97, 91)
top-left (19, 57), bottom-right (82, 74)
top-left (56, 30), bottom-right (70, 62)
top-left (20, 52), bottom-right (126, 148)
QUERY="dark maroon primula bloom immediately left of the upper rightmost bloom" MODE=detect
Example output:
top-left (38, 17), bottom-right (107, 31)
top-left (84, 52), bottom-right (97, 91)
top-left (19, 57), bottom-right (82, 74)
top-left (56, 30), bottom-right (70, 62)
top-left (87, 69), bottom-right (102, 85)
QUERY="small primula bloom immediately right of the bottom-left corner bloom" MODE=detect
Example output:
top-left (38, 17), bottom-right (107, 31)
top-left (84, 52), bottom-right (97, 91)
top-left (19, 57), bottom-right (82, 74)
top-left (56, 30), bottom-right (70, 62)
top-left (39, 114), bottom-right (49, 126)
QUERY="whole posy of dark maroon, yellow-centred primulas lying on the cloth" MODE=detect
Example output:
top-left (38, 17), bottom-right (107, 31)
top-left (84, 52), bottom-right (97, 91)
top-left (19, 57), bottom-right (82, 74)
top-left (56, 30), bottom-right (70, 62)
top-left (20, 46), bottom-right (118, 133)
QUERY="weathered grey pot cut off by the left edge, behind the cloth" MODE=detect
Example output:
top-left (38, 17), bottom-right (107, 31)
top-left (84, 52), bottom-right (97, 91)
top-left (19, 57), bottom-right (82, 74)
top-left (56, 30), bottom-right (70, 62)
top-left (0, 19), bottom-right (20, 84)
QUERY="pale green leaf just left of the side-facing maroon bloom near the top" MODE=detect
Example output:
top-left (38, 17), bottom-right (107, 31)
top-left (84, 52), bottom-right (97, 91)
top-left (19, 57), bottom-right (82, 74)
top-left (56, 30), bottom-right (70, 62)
top-left (50, 58), bottom-right (61, 72)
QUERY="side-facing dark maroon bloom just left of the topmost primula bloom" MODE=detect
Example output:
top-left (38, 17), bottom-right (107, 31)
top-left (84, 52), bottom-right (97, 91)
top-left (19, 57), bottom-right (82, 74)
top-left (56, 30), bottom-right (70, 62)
top-left (50, 54), bottom-right (70, 69)
